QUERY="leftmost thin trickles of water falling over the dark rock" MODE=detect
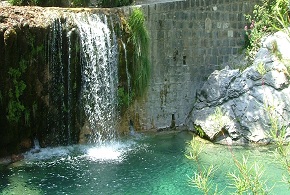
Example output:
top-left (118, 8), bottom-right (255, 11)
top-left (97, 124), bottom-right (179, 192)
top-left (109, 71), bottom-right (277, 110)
top-left (47, 18), bottom-right (67, 144)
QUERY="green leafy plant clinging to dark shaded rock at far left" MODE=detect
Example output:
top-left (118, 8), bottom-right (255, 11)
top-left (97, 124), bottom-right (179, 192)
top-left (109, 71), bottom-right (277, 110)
top-left (7, 60), bottom-right (27, 123)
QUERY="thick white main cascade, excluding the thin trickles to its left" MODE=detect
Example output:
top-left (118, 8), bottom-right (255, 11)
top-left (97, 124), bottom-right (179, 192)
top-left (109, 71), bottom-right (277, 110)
top-left (73, 12), bottom-right (118, 143)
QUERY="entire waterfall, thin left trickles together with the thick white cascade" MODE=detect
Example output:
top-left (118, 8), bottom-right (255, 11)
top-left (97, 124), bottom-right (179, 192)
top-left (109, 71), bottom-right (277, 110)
top-left (46, 12), bottom-right (119, 145)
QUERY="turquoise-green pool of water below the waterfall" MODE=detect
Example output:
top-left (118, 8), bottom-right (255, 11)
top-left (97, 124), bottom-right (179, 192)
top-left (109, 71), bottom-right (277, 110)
top-left (0, 132), bottom-right (290, 195)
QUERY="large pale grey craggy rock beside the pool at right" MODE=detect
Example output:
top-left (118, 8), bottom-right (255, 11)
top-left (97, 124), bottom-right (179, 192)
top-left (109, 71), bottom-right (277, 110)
top-left (189, 29), bottom-right (290, 144)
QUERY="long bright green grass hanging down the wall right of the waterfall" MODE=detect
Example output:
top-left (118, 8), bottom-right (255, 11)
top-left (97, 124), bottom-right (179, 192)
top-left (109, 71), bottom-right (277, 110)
top-left (128, 8), bottom-right (150, 97)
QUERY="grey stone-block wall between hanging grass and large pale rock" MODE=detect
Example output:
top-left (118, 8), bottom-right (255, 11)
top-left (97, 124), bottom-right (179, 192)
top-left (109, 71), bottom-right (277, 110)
top-left (126, 0), bottom-right (259, 130)
